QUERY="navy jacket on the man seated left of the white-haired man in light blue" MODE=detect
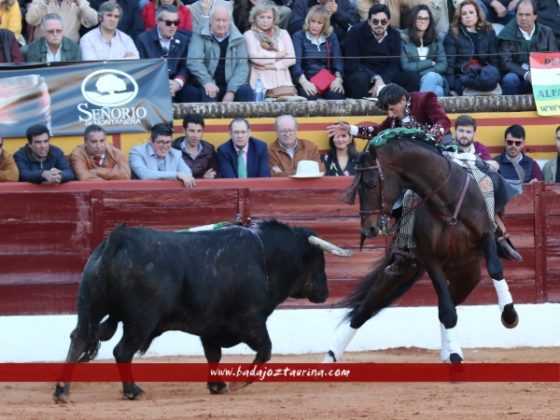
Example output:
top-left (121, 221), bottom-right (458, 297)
top-left (136, 28), bottom-right (191, 83)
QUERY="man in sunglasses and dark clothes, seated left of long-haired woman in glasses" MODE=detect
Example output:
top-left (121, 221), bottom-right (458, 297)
top-left (343, 4), bottom-right (418, 99)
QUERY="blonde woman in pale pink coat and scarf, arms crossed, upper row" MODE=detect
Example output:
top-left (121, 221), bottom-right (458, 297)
top-left (243, 1), bottom-right (296, 97)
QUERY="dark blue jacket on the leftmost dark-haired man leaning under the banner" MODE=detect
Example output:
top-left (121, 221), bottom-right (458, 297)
top-left (14, 144), bottom-right (75, 184)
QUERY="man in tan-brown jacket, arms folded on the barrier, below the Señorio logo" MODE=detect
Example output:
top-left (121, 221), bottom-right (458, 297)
top-left (70, 124), bottom-right (130, 181)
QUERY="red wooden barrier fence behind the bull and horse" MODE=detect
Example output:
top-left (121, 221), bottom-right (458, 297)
top-left (0, 177), bottom-right (560, 315)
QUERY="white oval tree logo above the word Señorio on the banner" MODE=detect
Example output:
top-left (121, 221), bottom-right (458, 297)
top-left (82, 69), bottom-right (138, 107)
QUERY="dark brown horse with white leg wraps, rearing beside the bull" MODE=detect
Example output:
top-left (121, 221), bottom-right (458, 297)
top-left (325, 129), bottom-right (518, 362)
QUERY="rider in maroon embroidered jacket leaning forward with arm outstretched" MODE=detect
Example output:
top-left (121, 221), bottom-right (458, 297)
top-left (327, 84), bottom-right (521, 276)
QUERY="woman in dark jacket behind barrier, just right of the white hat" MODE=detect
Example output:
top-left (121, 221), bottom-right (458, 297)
top-left (324, 124), bottom-right (358, 176)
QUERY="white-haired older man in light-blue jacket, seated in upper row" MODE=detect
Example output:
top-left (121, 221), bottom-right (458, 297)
top-left (187, 4), bottom-right (253, 102)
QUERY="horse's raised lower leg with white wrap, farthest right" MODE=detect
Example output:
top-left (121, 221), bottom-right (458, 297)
top-left (482, 235), bottom-right (519, 328)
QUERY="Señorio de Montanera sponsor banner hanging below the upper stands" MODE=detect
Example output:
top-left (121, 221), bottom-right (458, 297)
top-left (0, 59), bottom-right (173, 137)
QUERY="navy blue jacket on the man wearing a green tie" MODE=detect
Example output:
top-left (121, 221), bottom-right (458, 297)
top-left (218, 137), bottom-right (270, 178)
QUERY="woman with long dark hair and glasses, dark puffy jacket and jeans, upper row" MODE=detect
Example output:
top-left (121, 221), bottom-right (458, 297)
top-left (401, 4), bottom-right (448, 96)
